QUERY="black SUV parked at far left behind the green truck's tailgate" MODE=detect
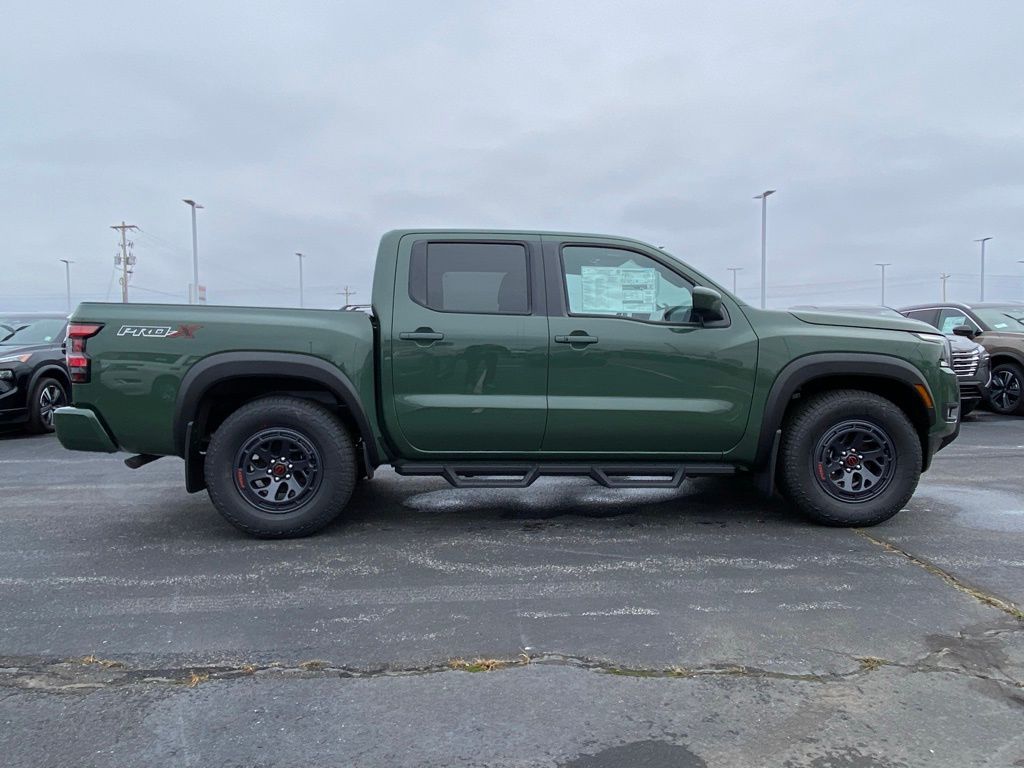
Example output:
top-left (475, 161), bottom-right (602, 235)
top-left (0, 314), bottom-right (71, 432)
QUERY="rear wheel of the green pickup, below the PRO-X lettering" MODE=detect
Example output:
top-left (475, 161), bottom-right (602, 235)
top-left (204, 397), bottom-right (356, 539)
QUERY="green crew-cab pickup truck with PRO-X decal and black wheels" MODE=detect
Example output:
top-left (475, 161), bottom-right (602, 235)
top-left (55, 229), bottom-right (959, 538)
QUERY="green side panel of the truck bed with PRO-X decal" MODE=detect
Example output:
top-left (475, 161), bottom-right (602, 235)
top-left (72, 302), bottom-right (374, 455)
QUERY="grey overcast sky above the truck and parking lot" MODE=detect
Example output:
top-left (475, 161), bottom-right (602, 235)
top-left (0, 0), bottom-right (1024, 310)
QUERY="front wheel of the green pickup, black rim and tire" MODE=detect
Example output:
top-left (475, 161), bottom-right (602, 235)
top-left (779, 390), bottom-right (922, 526)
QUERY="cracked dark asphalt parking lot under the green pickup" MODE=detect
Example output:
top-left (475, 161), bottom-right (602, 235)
top-left (0, 414), bottom-right (1024, 768)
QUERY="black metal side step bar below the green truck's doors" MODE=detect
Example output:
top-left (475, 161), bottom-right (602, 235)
top-left (394, 462), bottom-right (736, 488)
